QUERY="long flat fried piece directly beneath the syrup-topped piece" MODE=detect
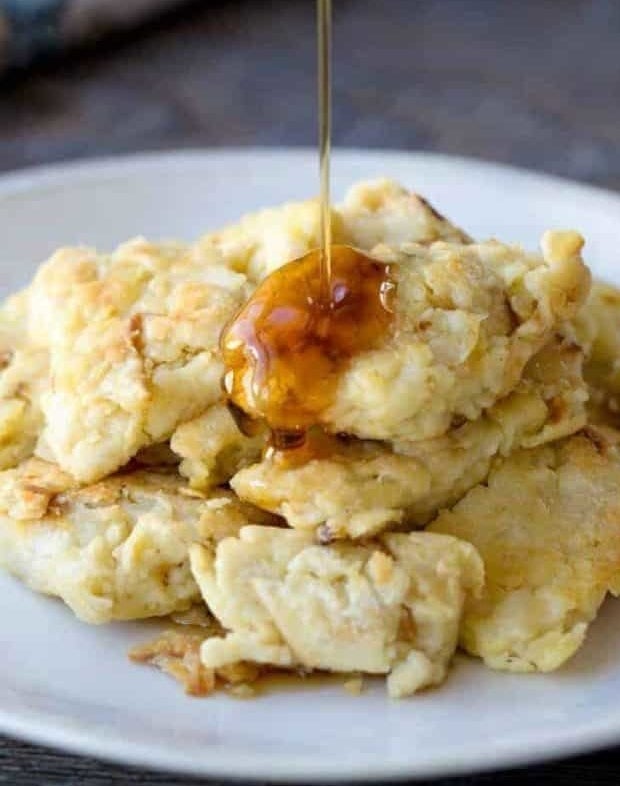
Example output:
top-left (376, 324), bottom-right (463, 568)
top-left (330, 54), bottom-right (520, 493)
top-left (231, 339), bottom-right (587, 540)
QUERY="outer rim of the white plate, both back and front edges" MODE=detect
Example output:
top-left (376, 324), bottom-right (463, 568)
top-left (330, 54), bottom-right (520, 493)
top-left (0, 146), bottom-right (620, 782)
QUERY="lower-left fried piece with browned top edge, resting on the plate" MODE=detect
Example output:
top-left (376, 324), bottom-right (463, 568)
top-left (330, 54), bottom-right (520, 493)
top-left (0, 459), bottom-right (270, 623)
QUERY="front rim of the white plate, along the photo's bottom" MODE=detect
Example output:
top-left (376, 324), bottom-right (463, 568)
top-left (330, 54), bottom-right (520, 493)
top-left (0, 675), bottom-right (620, 784)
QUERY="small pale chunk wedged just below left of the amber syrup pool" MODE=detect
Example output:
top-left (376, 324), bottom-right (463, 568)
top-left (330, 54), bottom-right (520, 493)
top-left (170, 404), bottom-right (266, 489)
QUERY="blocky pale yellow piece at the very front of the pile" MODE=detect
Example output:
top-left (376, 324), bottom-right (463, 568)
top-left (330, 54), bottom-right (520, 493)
top-left (191, 527), bottom-right (483, 697)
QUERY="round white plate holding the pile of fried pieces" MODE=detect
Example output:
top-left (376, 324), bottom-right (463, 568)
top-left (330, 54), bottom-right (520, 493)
top-left (0, 150), bottom-right (620, 781)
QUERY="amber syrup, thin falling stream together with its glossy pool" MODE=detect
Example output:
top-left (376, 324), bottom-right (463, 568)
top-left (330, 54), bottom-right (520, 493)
top-left (221, 0), bottom-right (395, 456)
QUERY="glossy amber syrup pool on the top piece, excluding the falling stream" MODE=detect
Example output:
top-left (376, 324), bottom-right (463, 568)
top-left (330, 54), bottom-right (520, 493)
top-left (221, 246), bottom-right (395, 451)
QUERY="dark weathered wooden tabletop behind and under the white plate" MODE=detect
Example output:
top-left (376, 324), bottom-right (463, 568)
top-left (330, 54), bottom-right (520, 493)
top-left (0, 0), bottom-right (620, 786)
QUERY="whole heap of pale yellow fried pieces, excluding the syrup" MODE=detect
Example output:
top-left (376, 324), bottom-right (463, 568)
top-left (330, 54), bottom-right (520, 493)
top-left (0, 180), bottom-right (620, 696)
